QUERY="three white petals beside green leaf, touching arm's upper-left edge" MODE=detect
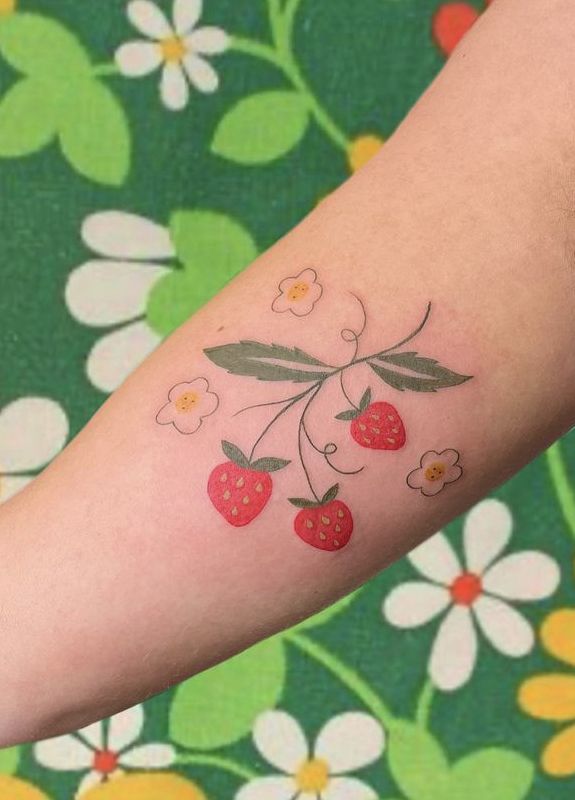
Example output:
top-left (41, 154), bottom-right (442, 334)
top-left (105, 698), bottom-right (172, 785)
top-left (66, 211), bottom-right (175, 392)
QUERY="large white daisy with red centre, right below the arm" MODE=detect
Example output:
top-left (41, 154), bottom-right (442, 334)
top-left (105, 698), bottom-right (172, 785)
top-left (383, 499), bottom-right (560, 691)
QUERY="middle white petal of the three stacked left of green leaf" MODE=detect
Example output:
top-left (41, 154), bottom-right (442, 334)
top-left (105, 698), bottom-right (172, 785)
top-left (66, 261), bottom-right (170, 327)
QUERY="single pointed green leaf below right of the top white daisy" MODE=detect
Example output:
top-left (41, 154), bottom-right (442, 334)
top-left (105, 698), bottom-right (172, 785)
top-left (212, 90), bottom-right (310, 164)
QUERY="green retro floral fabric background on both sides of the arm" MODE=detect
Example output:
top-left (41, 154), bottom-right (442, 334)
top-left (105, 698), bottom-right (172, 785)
top-left (0, 0), bottom-right (575, 800)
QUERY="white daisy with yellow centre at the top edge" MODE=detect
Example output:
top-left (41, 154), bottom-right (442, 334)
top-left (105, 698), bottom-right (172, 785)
top-left (116, 0), bottom-right (229, 111)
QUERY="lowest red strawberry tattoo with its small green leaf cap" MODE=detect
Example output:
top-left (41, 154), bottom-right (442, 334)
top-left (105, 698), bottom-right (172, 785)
top-left (290, 485), bottom-right (353, 551)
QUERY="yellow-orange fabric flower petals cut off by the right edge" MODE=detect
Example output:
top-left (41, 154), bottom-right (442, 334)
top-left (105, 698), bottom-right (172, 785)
top-left (519, 608), bottom-right (575, 777)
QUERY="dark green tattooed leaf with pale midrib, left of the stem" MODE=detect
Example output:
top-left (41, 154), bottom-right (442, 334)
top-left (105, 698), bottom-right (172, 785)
top-left (204, 341), bottom-right (331, 383)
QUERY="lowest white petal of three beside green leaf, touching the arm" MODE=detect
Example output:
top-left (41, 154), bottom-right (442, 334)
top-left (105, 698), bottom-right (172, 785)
top-left (87, 322), bottom-right (160, 392)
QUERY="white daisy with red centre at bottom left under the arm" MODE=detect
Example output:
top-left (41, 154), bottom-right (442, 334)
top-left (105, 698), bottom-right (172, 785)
top-left (34, 705), bottom-right (176, 797)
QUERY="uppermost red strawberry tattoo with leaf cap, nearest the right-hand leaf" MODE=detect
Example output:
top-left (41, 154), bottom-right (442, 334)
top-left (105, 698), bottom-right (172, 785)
top-left (336, 389), bottom-right (405, 450)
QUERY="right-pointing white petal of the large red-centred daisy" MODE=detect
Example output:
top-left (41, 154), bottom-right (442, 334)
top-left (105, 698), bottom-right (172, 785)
top-left (483, 550), bottom-right (561, 600)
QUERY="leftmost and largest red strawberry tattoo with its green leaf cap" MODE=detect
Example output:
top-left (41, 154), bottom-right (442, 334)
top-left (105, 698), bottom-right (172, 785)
top-left (208, 442), bottom-right (289, 528)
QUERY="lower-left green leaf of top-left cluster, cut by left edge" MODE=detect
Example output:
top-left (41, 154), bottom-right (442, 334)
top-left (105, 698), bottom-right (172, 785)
top-left (0, 78), bottom-right (56, 158)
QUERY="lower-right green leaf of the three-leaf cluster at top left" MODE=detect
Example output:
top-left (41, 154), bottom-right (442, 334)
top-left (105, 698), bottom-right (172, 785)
top-left (58, 79), bottom-right (131, 186)
